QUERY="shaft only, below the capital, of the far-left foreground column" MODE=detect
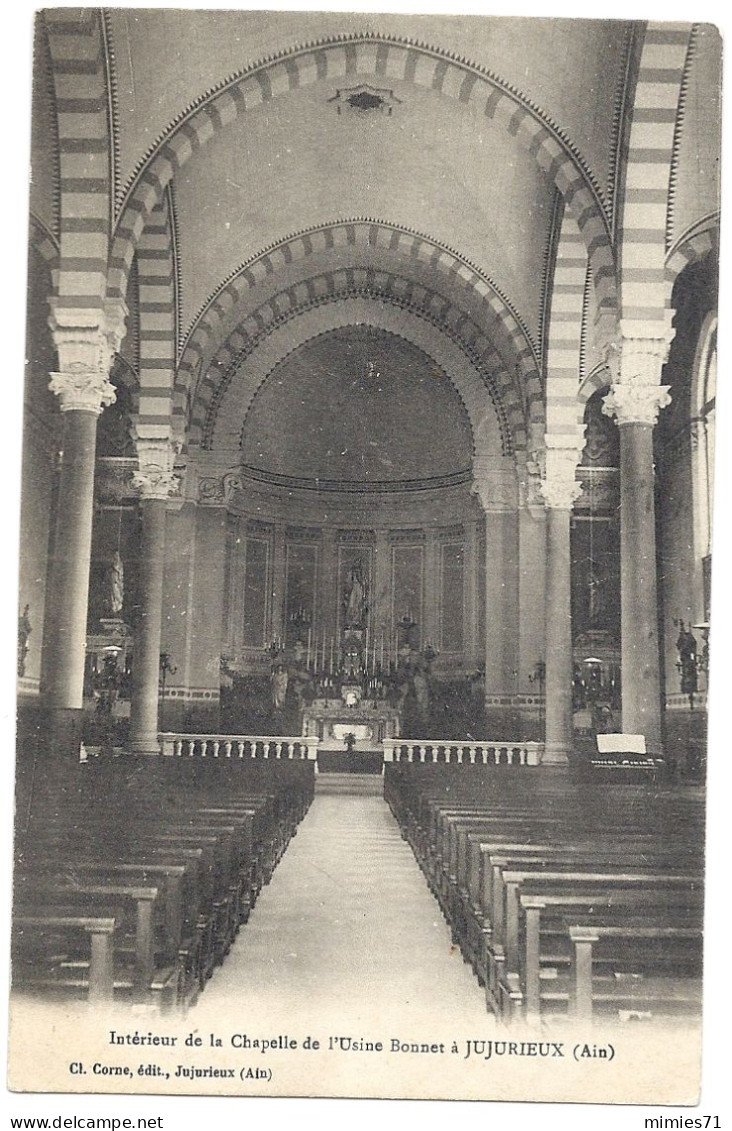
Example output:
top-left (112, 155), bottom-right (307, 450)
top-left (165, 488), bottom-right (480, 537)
top-left (43, 409), bottom-right (98, 713)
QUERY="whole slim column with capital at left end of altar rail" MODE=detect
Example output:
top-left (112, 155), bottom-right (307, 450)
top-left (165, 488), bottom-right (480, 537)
top-left (130, 439), bottom-right (178, 754)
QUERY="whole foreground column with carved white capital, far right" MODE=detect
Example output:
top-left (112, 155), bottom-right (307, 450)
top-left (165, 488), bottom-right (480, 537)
top-left (603, 323), bottom-right (673, 754)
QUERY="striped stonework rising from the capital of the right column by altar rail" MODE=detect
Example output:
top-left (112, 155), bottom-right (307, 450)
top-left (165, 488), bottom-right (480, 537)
top-left (546, 209), bottom-right (588, 447)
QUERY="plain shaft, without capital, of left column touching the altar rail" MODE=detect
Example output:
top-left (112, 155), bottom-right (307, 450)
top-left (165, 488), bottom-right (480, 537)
top-left (130, 499), bottom-right (166, 754)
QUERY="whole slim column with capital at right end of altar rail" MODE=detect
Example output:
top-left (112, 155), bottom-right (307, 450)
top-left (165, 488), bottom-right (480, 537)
top-left (541, 430), bottom-right (584, 766)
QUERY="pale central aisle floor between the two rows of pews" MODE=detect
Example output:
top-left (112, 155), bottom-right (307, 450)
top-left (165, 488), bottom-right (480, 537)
top-left (190, 778), bottom-right (491, 1033)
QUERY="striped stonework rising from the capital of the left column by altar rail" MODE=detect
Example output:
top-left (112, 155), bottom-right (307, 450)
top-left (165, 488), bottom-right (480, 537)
top-left (136, 188), bottom-right (178, 439)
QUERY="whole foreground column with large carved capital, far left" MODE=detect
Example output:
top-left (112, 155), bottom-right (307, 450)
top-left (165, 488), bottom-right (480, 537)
top-left (43, 303), bottom-right (127, 752)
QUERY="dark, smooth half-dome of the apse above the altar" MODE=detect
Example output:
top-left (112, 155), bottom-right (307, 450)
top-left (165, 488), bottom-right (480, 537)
top-left (237, 326), bottom-right (473, 486)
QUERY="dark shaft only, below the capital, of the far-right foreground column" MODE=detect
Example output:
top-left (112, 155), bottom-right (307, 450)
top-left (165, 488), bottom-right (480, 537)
top-left (620, 422), bottom-right (661, 752)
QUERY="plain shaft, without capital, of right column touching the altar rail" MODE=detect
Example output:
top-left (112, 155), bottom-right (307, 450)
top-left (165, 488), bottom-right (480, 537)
top-left (543, 507), bottom-right (574, 765)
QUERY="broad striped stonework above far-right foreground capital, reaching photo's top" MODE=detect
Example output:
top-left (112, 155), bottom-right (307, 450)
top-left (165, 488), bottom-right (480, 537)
top-left (619, 23), bottom-right (692, 326)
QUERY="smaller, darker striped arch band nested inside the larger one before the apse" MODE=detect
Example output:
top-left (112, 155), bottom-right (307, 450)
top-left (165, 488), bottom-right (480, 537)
top-left (189, 279), bottom-right (518, 455)
